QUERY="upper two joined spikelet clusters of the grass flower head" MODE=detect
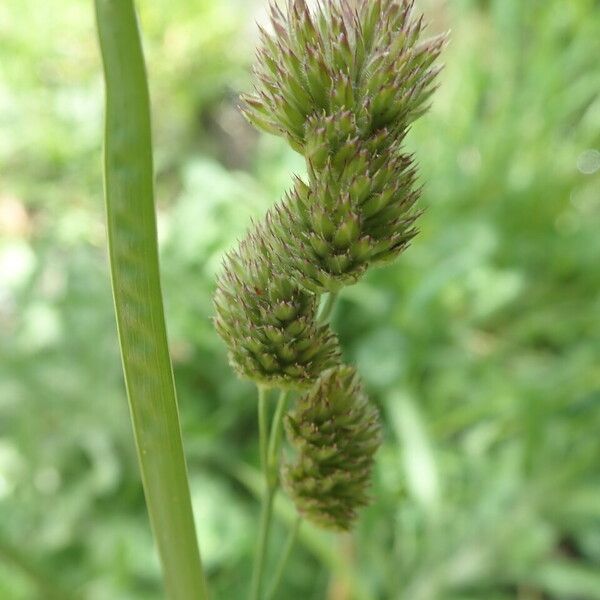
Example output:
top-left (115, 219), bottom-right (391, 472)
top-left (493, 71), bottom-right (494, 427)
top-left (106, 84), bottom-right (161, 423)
top-left (243, 0), bottom-right (445, 293)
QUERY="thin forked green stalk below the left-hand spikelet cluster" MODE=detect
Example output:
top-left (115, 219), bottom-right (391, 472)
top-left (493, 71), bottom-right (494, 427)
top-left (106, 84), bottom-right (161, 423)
top-left (250, 387), bottom-right (288, 600)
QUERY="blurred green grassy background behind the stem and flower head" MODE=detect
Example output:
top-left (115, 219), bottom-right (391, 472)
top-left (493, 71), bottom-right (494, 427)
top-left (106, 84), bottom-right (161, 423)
top-left (0, 0), bottom-right (600, 600)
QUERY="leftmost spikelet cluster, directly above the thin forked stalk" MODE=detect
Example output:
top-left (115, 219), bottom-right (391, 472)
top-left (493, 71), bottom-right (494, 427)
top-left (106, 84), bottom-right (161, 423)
top-left (214, 221), bottom-right (339, 389)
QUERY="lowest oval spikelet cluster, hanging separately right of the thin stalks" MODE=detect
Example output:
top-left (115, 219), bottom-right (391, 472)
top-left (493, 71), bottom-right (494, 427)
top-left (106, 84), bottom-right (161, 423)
top-left (283, 366), bottom-right (380, 530)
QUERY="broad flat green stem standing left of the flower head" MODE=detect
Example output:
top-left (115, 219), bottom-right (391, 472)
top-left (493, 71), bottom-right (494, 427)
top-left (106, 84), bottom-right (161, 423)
top-left (95, 0), bottom-right (207, 600)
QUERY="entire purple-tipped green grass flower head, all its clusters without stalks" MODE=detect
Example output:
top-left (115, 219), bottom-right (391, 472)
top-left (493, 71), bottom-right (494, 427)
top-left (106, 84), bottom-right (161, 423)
top-left (215, 0), bottom-right (445, 529)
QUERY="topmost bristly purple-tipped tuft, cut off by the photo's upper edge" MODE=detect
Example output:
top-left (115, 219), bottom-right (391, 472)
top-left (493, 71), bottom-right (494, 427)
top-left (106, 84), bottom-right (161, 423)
top-left (242, 0), bottom-right (445, 154)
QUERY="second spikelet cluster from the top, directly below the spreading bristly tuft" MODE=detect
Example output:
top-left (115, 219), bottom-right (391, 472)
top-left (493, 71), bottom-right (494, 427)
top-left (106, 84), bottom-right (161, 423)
top-left (267, 112), bottom-right (420, 294)
